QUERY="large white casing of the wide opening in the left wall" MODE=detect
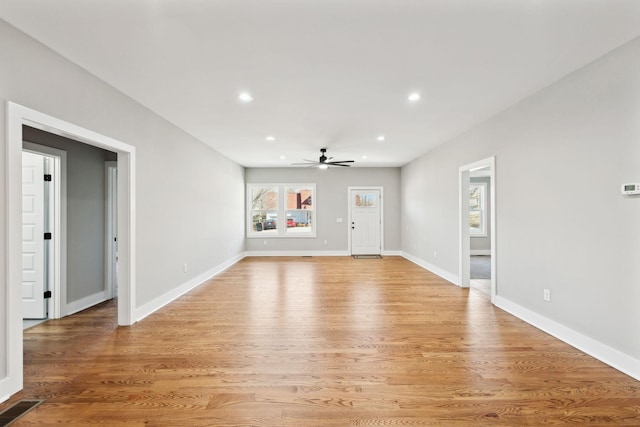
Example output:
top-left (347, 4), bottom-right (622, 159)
top-left (0, 101), bottom-right (136, 399)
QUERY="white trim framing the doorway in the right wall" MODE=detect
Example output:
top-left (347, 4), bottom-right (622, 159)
top-left (458, 156), bottom-right (498, 303)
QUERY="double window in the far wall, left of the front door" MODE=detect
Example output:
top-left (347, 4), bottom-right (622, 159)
top-left (247, 184), bottom-right (316, 238)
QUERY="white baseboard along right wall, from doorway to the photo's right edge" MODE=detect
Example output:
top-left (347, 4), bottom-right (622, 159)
top-left (494, 295), bottom-right (640, 381)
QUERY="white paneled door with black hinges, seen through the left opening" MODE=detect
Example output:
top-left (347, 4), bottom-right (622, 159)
top-left (22, 151), bottom-right (47, 319)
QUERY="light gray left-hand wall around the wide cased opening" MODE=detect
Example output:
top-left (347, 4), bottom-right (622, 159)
top-left (0, 20), bottom-right (244, 400)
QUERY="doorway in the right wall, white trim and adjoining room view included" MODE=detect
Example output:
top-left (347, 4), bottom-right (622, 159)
top-left (459, 157), bottom-right (497, 302)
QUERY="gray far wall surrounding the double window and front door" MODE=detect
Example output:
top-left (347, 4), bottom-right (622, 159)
top-left (246, 167), bottom-right (400, 252)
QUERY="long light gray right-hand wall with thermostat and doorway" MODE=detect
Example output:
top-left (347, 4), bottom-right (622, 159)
top-left (402, 39), bottom-right (640, 378)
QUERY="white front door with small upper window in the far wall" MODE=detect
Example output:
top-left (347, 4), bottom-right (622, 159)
top-left (349, 189), bottom-right (382, 255)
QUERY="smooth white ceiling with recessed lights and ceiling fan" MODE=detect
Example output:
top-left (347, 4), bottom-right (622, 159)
top-left (0, 0), bottom-right (640, 167)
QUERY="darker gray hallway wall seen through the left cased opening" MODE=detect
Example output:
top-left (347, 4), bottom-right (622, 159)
top-left (22, 126), bottom-right (107, 303)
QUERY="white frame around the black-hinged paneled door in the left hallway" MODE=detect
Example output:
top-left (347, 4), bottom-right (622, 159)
top-left (22, 141), bottom-right (67, 319)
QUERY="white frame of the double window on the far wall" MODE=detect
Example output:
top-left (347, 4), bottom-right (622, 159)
top-left (245, 182), bottom-right (318, 239)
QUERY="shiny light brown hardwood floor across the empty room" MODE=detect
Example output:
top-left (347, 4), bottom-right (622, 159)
top-left (5, 257), bottom-right (640, 426)
